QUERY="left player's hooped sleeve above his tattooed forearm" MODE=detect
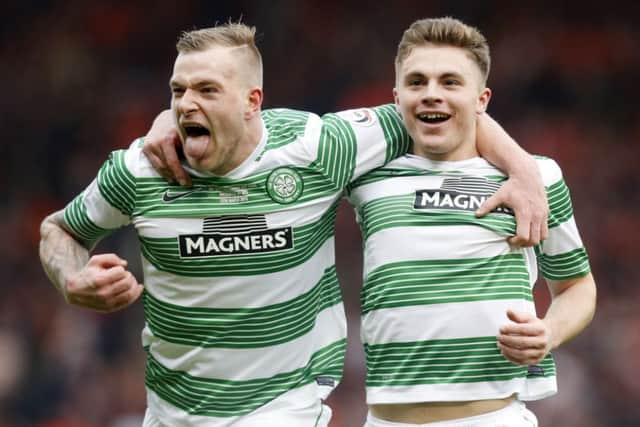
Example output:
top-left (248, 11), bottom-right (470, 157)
top-left (64, 143), bottom-right (136, 246)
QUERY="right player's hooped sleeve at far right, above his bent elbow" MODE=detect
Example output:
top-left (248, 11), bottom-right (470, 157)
top-left (536, 158), bottom-right (591, 280)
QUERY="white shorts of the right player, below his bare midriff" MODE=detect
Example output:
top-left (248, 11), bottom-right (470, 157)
top-left (364, 400), bottom-right (538, 427)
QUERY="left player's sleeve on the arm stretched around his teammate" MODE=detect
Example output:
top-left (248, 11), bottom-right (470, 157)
top-left (317, 105), bottom-right (411, 188)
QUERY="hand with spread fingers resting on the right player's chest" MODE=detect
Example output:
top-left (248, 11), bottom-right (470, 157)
top-left (475, 173), bottom-right (549, 246)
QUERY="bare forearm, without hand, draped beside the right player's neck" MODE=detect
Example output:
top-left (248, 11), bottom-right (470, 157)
top-left (476, 113), bottom-right (539, 178)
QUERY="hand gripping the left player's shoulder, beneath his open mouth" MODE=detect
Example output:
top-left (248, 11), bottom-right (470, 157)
top-left (142, 110), bottom-right (191, 187)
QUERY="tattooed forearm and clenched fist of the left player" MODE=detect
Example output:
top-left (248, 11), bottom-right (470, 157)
top-left (40, 211), bottom-right (143, 312)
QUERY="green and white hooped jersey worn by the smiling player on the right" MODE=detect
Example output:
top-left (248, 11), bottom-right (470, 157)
top-left (349, 155), bottom-right (590, 404)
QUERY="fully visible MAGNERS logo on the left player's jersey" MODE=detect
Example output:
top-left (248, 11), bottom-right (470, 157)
top-left (178, 215), bottom-right (293, 258)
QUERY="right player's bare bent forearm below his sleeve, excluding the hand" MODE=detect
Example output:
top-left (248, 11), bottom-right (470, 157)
top-left (543, 274), bottom-right (596, 349)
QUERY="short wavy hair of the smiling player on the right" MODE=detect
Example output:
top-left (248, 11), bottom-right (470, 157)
top-left (395, 16), bottom-right (491, 84)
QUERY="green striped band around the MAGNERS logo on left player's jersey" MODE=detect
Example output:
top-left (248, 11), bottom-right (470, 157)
top-left (139, 202), bottom-right (337, 277)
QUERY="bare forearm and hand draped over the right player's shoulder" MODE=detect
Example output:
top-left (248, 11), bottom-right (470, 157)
top-left (476, 113), bottom-right (549, 246)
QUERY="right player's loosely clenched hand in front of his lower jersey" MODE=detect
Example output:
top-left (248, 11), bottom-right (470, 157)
top-left (498, 310), bottom-right (552, 366)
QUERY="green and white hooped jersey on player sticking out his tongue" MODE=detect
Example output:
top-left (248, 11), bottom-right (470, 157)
top-left (65, 105), bottom-right (410, 426)
